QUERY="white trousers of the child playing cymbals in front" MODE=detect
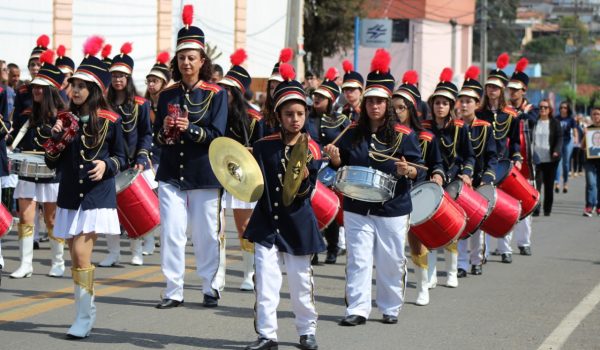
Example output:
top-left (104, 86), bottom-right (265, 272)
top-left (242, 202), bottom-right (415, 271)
top-left (254, 244), bottom-right (318, 340)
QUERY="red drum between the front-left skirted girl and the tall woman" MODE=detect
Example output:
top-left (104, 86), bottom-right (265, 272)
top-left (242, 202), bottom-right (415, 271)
top-left (115, 169), bottom-right (160, 238)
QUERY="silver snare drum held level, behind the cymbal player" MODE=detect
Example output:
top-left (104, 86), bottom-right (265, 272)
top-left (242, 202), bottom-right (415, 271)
top-left (334, 166), bottom-right (396, 203)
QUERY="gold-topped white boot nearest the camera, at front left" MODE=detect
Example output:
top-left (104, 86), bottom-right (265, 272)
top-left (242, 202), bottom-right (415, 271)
top-left (67, 266), bottom-right (96, 339)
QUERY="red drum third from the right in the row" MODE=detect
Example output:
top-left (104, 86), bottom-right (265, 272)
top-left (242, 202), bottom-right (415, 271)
top-left (446, 180), bottom-right (489, 239)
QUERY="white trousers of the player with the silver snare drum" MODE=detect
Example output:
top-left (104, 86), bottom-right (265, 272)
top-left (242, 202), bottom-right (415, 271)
top-left (344, 211), bottom-right (409, 318)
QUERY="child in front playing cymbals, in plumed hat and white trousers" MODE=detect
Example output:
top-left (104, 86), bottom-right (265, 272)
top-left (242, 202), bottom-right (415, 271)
top-left (244, 63), bottom-right (325, 350)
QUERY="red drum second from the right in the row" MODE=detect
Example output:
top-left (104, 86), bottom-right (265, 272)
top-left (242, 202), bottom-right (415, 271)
top-left (477, 185), bottom-right (521, 238)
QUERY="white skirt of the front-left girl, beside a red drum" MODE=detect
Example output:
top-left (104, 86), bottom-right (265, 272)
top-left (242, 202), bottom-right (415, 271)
top-left (54, 207), bottom-right (121, 239)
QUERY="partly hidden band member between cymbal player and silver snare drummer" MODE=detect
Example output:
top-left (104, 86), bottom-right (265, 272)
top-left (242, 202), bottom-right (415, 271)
top-left (305, 67), bottom-right (350, 265)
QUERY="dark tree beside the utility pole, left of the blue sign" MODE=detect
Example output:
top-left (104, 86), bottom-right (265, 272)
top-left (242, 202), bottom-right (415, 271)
top-left (304, 0), bottom-right (363, 73)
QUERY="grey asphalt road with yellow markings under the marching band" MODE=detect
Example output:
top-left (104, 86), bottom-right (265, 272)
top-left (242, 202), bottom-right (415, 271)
top-left (0, 177), bottom-right (600, 350)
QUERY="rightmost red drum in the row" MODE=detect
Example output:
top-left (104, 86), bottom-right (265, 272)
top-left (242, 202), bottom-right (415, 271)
top-left (498, 160), bottom-right (540, 219)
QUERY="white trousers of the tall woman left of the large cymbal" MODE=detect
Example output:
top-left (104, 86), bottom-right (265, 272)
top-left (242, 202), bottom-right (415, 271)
top-left (158, 182), bottom-right (222, 301)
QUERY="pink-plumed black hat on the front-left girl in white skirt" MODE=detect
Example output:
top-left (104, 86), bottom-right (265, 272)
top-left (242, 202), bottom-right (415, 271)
top-left (69, 36), bottom-right (110, 92)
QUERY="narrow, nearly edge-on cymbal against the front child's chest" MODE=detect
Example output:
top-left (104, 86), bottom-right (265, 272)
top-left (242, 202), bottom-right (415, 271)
top-left (282, 134), bottom-right (308, 207)
